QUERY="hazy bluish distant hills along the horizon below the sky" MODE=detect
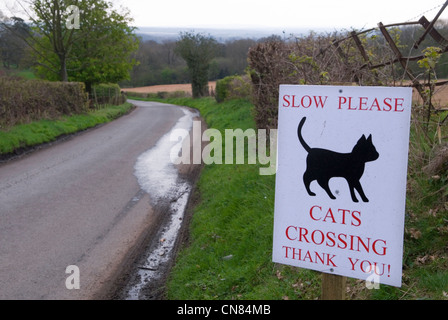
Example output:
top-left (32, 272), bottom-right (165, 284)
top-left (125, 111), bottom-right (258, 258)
top-left (136, 27), bottom-right (316, 42)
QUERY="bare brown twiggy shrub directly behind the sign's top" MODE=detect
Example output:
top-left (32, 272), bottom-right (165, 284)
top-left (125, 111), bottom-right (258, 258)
top-left (248, 31), bottom-right (404, 129)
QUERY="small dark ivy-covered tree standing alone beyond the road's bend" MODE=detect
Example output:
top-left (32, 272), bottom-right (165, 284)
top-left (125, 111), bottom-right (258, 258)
top-left (176, 32), bottom-right (217, 98)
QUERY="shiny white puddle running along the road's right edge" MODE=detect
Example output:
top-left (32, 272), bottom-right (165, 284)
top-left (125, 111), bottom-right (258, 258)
top-left (125, 108), bottom-right (199, 300)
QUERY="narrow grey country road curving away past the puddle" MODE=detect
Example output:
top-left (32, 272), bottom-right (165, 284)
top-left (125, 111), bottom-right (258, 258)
top-left (0, 101), bottom-right (191, 299)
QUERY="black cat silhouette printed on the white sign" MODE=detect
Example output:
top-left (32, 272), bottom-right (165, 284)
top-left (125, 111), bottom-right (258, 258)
top-left (297, 117), bottom-right (379, 202)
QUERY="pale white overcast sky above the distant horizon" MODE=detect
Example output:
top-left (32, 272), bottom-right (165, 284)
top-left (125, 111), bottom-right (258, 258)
top-left (0, 0), bottom-right (448, 30)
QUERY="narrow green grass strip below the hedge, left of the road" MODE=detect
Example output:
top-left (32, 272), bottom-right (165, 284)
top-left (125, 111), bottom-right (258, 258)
top-left (0, 103), bottom-right (132, 155)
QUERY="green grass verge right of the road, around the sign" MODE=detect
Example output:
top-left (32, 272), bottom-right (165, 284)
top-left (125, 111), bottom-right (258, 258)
top-left (144, 98), bottom-right (448, 300)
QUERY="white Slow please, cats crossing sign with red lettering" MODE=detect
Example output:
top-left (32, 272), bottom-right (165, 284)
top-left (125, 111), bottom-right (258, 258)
top-left (273, 85), bottom-right (412, 287)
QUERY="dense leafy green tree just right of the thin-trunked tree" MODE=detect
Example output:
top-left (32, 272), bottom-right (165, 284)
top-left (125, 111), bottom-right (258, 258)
top-left (61, 0), bottom-right (139, 92)
